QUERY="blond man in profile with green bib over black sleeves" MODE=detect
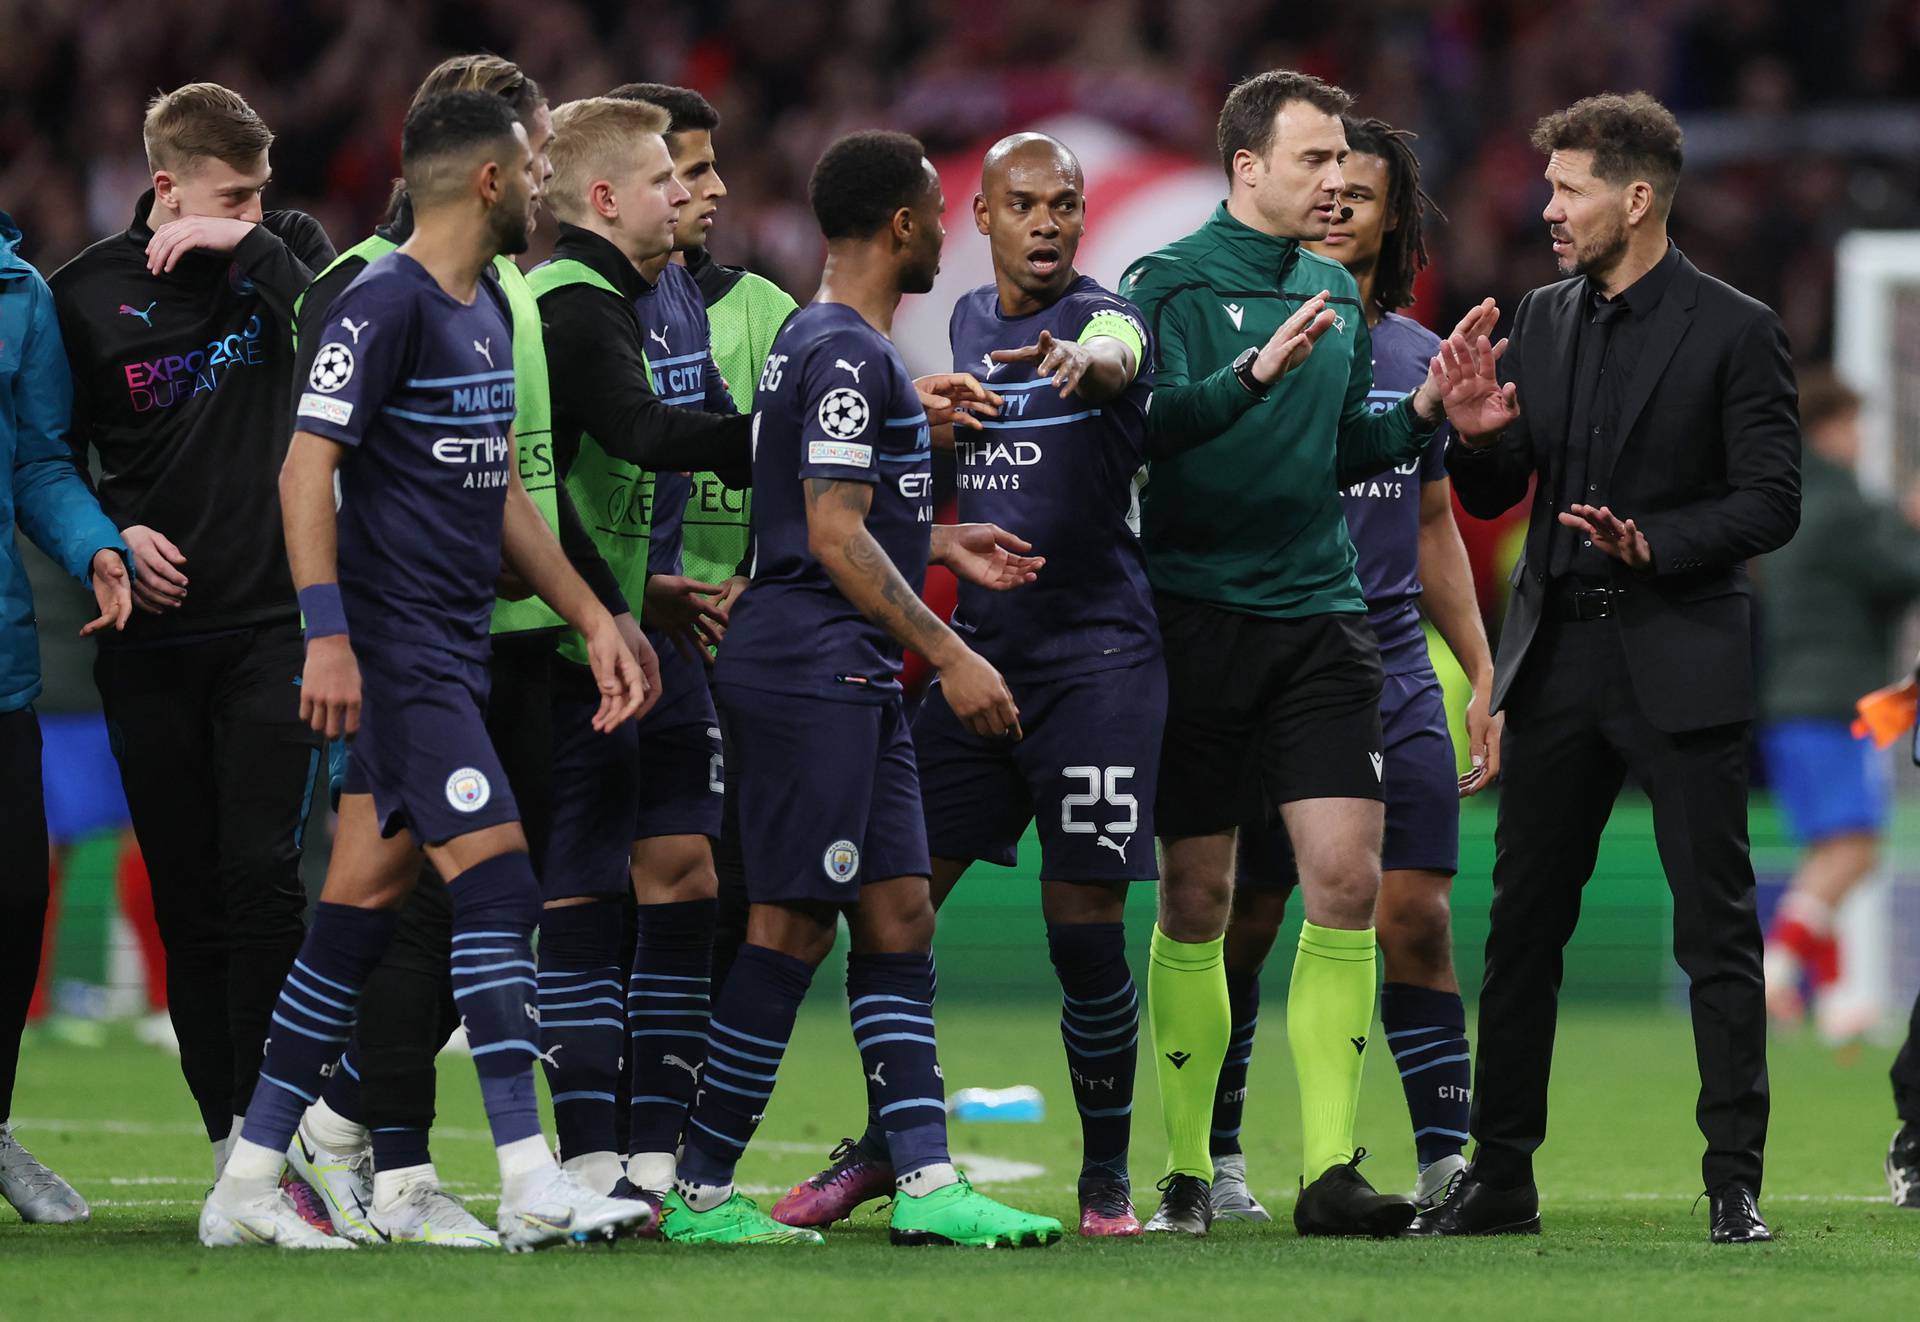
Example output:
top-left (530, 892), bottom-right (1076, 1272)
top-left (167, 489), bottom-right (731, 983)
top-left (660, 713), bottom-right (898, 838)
top-left (530, 98), bottom-right (753, 1203)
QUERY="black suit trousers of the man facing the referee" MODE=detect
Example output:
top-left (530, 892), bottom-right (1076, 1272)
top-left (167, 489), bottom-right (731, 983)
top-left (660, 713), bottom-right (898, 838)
top-left (1473, 620), bottom-right (1768, 1192)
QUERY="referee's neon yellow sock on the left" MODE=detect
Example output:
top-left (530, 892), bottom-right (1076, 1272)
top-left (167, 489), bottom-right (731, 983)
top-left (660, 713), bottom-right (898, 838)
top-left (1146, 925), bottom-right (1233, 1180)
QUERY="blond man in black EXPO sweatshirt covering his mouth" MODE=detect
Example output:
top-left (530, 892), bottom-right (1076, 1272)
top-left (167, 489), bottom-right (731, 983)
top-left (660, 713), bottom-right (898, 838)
top-left (50, 83), bottom-right (334, 1169)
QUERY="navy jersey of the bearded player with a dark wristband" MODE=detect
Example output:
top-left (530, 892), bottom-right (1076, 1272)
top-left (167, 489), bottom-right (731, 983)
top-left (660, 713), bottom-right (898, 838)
top-left (294, 251), bottom-right (515, 660)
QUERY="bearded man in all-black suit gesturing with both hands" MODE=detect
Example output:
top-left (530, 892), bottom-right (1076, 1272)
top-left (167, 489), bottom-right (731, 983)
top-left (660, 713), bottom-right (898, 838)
top-left (1407, 92), bottom-right (1801, 1243)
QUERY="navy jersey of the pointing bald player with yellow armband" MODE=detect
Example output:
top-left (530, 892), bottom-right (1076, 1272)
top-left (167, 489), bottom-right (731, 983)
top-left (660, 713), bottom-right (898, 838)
top-left (948, 276), bottom-right (1160, 679)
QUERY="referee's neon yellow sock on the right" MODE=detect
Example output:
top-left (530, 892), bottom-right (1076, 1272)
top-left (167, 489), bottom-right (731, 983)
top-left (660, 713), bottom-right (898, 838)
top-left (1286, 923), bottom-right (1375, 1182)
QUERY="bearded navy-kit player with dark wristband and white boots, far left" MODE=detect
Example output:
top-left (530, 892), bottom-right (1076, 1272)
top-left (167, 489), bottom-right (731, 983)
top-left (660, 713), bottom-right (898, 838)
top-left (200, 92), bottom-right (651, 1251)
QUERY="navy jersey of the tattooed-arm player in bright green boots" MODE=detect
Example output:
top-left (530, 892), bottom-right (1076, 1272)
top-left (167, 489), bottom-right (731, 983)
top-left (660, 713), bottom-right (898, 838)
top-left (714, 303), bottom-right (933, 702)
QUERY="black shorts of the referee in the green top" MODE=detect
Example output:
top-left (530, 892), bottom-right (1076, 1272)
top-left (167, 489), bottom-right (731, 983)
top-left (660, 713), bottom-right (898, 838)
top-left (1154, 593), bottom-right (1384, 838)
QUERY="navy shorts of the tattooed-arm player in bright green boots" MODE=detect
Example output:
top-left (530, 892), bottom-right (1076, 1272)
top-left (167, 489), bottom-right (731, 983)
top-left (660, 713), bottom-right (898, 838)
top-left (714, 683), bottom-right (931, 906)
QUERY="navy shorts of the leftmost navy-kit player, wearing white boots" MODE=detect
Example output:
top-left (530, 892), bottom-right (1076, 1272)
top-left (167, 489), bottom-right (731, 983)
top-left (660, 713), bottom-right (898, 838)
top-left (342, 639), bottom-right (520, 844)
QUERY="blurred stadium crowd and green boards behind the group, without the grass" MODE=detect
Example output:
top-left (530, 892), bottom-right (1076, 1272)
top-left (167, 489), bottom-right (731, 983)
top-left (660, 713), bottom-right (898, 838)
top-left (15, 0), bottom-right (1920, 1017)
